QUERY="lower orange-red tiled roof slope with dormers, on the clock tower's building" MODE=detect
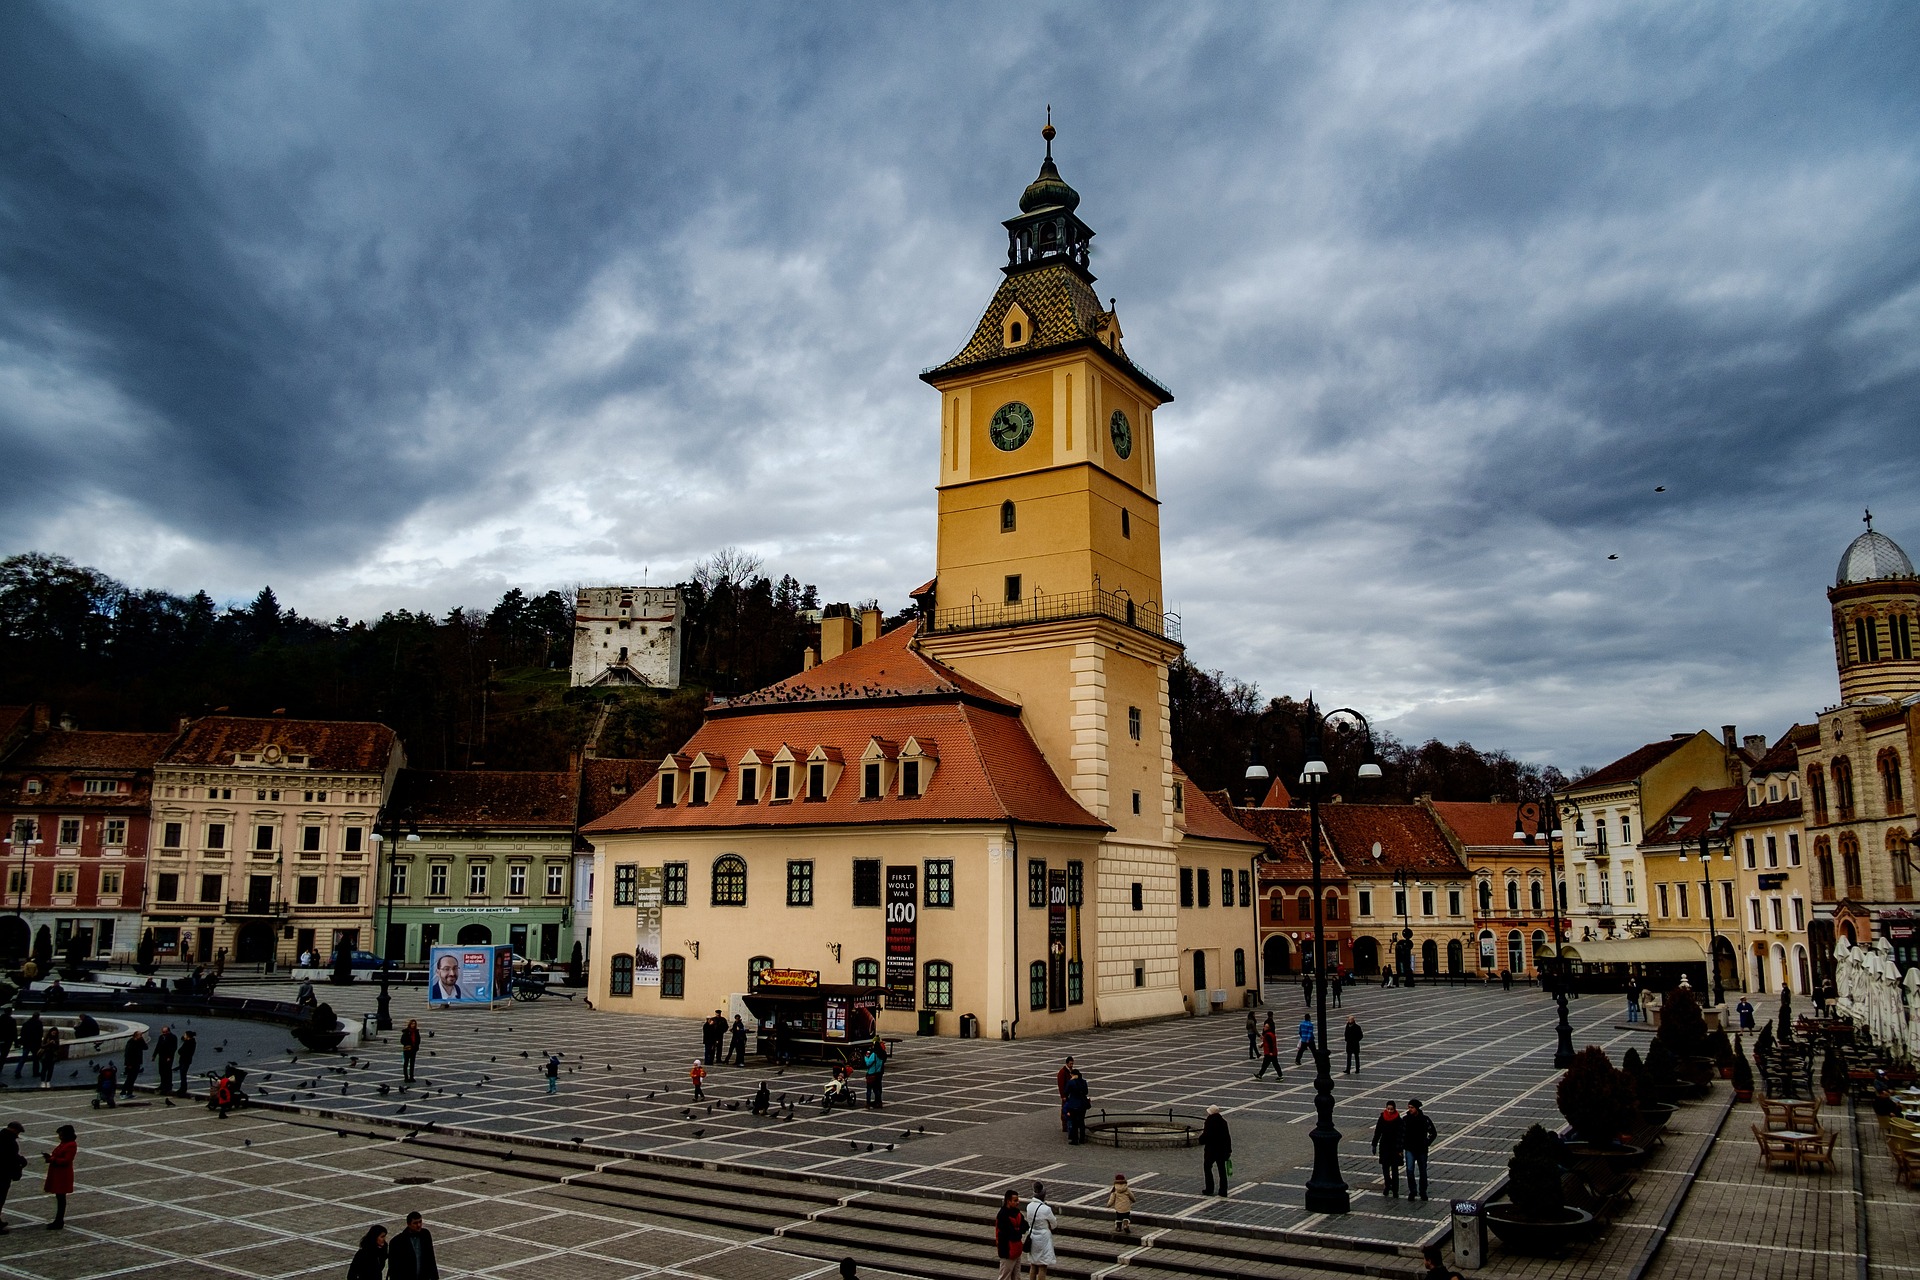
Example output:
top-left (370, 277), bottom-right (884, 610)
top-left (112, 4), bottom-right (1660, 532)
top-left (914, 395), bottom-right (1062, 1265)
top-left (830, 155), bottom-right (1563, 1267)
top-left (586, 694), bottom-right (1108, 833)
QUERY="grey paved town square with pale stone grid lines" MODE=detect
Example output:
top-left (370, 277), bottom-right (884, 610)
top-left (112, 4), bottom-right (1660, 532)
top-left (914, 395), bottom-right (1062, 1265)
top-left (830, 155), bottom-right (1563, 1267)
top-left (0, 986), bottom-right (1920, 1280)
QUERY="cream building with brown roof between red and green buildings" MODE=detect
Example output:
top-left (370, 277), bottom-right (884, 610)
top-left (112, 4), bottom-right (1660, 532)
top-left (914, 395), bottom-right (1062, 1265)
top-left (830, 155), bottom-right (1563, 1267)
top-left (144, 716), bottom-right (405, 965)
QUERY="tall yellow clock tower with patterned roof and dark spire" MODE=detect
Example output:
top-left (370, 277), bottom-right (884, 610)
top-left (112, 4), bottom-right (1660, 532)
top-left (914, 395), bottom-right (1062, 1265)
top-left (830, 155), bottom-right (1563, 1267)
top-left (920, 121), bottom-right (1183, 1021)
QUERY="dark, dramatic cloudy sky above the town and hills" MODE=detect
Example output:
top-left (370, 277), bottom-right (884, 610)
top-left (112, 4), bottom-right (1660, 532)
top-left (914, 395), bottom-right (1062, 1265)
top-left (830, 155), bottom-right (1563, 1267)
top-left (0, 0), bottom-right (1920, 766)
